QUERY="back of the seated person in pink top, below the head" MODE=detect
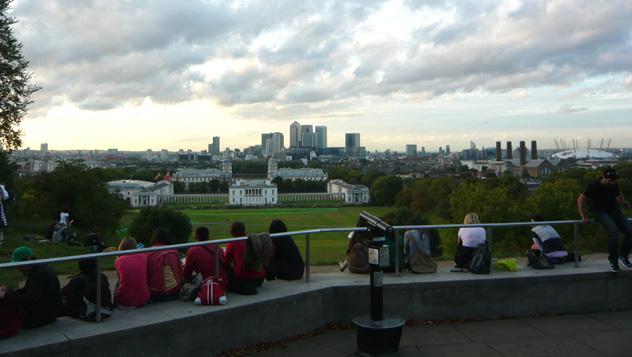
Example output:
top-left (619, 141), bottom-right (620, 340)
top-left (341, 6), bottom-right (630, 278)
top-left (114, 253), bottom-right (150, 307)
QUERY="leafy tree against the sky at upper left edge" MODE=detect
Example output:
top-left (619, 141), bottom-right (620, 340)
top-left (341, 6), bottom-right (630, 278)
top-left (0, 0), bottom-right (39, 150)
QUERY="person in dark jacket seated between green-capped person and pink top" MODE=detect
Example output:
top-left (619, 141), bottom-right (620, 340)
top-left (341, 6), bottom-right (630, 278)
top-left (61, 259), bottom-right (113, 321)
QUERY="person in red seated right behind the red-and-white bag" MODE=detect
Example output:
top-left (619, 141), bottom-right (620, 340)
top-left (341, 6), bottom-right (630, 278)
top-left (183, 227), bottom-right (228, 288)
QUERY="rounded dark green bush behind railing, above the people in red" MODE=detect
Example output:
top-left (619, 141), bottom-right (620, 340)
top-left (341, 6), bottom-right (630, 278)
top-left (129, 207), bottom-right (193, 245)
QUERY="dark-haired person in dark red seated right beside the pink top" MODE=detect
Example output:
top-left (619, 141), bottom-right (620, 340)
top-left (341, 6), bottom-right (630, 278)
top-left (147, 228), bottom-right (184, 302)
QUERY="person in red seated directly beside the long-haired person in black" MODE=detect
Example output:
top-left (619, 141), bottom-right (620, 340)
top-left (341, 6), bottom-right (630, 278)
top-left (224, 222), bottom-right (266, 295)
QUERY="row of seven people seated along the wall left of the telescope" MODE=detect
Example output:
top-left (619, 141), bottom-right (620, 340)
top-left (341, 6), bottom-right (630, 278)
top-left (0, 220), bottom-right (305, 338)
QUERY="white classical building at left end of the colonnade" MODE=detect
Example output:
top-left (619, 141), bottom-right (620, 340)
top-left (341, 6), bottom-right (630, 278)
top-left (107, 180), bottom-right (173, 207)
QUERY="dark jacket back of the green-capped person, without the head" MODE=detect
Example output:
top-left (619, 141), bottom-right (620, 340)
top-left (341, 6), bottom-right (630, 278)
top-left (7, 264), bottom-right (61, 329)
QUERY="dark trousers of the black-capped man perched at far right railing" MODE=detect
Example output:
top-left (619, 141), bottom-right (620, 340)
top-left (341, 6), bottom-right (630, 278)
top-left (595, 208), bottom-right (632, 262)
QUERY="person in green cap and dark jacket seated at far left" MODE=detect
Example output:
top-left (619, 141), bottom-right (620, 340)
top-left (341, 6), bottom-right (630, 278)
top-left (0, 247), bottom-right (61, 329)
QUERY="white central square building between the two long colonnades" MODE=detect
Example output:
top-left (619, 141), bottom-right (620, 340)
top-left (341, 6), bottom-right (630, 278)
top-left (228, 180), bottom-right (279, 206)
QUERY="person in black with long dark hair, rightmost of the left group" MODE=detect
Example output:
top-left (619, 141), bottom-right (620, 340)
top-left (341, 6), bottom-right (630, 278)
top-left (266, 219), bottom-right (305, 280)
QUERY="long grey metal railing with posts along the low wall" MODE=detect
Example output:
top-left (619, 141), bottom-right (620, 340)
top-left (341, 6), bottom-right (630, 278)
top-left (0, 220), bottom-right (624, 321)
